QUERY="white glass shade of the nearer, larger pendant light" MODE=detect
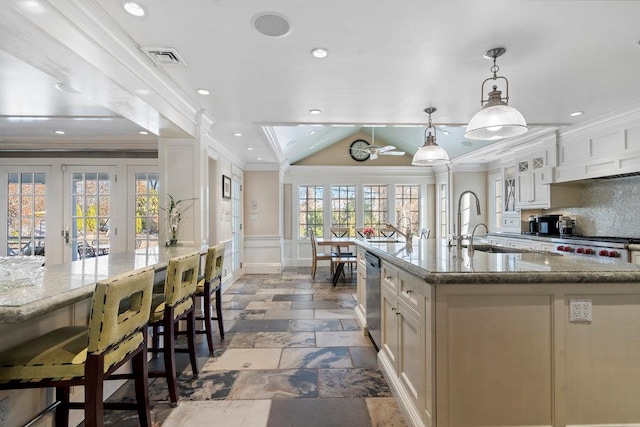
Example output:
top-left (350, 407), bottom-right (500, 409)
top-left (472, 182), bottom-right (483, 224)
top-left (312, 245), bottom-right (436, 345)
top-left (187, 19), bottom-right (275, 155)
top-left (464, 103), bottom-right (528, 140)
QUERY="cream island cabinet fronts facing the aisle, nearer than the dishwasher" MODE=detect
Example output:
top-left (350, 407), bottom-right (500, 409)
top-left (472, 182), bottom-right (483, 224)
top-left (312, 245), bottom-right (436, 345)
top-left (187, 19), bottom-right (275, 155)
top-left (379, 263), bottom-right (434, 426)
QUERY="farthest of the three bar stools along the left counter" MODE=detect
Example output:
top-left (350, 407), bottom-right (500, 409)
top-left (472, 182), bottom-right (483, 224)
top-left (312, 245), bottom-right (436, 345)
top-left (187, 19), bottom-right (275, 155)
top-left (195, 245), bottom-right (224, 356)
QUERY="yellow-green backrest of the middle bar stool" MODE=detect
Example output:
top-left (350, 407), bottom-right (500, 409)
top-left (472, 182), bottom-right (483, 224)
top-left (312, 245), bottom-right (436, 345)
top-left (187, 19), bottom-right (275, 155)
top-left (164, 252), bottom-right (200, 307)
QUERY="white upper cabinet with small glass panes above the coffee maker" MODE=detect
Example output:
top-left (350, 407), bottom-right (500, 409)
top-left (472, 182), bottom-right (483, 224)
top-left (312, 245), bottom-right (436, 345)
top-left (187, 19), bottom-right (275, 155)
top-left (516, 152), bottom-right (553, 209)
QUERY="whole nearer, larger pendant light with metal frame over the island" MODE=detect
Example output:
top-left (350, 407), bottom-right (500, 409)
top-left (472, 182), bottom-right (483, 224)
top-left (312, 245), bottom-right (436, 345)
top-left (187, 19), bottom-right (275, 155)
top-left (464, 47), bottom-right (528, 140)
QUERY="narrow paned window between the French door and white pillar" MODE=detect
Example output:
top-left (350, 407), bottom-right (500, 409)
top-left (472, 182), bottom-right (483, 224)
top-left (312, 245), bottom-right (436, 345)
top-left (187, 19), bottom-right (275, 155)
top-left (134, 173), bottom-right (160, 249)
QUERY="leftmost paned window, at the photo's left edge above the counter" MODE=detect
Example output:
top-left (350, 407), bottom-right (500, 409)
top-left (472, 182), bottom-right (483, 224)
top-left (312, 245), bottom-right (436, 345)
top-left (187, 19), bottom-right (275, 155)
top-left (7, 173), bottom-right (46, 256)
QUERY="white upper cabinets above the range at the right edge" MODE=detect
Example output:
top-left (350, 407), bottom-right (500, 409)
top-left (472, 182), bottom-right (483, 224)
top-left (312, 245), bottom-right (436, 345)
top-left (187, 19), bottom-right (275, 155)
top-left (555, 107), bottom-right (640, 182)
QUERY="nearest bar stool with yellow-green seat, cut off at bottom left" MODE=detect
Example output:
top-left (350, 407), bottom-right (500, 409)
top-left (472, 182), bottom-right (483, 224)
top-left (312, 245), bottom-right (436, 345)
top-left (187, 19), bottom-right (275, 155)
top-left (0, 268), bottom-right (153, 427)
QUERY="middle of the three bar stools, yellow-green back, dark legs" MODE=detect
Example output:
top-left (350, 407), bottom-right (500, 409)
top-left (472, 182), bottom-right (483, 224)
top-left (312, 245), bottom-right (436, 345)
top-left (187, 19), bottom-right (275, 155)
top-left (149, 252), bottom-right (200, 407)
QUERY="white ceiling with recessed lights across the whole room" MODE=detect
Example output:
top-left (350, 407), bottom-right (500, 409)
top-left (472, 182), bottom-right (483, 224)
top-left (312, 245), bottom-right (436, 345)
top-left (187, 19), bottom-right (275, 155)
top-left (0, 0), bottom-right (640, 168)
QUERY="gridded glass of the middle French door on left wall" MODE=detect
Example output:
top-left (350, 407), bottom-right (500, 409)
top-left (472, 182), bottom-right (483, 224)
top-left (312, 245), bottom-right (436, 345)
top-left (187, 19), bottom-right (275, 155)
top-left (70, 173), bottom-right (111, 261)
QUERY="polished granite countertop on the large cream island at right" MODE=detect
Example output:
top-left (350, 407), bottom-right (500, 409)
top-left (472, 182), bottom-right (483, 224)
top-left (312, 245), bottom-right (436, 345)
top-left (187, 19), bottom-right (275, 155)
top-left (356, 239), bottom-right (640, 284)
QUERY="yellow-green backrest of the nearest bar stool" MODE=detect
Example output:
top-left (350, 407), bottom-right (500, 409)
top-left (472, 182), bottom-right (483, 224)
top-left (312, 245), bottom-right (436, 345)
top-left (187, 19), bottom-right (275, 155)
top-left (87, 267), bottom-right (154, 354)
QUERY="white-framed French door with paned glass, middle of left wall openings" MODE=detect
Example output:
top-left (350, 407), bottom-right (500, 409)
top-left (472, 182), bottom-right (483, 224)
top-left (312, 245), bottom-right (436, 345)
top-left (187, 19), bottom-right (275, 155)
top-left (62, 166), bottom-right (117, 262)
